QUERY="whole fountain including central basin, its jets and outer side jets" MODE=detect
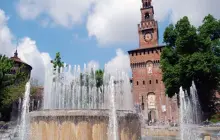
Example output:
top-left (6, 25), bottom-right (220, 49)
top-left (15, 66), bottom-right (218, 140)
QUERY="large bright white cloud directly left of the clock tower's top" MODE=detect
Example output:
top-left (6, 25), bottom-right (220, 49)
top-left (87, 0), bottom-right (141, 44)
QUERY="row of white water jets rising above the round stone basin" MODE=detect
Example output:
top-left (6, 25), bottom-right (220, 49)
top-left (43, 65), bottom-right (133, 110)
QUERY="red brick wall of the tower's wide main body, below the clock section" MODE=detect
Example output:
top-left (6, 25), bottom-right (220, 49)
top-left (129, 47), bottom-right (178, 121)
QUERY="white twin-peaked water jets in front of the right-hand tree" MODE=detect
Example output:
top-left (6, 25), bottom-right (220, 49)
top-left (179, 82), bottom-right (201, 140)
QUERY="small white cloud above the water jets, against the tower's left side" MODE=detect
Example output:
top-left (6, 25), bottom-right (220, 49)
top-left (105, 49), bottom-right (131, 73)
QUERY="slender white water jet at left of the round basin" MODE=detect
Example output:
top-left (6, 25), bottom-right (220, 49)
top-left (19, 82), bottom-right (30, 140)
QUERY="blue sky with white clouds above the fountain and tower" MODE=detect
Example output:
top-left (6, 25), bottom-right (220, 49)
top-left (0, 0), bottom-right (220, 82)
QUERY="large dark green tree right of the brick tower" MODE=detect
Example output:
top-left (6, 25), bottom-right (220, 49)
top-left (161, 15), bottom-right (220, 115)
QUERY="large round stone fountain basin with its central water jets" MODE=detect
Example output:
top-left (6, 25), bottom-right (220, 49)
top-left (26, 66), bottom-right (141, 140)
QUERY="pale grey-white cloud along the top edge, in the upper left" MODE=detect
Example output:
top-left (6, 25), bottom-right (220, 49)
top-left (17, 0), bottom-right (95, 27)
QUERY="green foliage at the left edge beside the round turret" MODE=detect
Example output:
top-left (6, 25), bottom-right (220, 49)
top-left (0, 55), bottom-right (28, 109)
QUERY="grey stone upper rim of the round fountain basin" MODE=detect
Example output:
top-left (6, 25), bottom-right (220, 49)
top-left (29, 109), bottom-right (138, 118)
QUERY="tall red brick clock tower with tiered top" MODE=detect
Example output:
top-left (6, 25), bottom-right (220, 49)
top-left (128, 0), bottom-right (178, 122)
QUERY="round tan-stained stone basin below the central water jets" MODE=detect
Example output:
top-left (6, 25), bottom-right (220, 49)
top-left (30, 110), bottom-right (141, 140)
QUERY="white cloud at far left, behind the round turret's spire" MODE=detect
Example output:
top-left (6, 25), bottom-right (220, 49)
top-left (0, 9), bottom-right (51, 83)
